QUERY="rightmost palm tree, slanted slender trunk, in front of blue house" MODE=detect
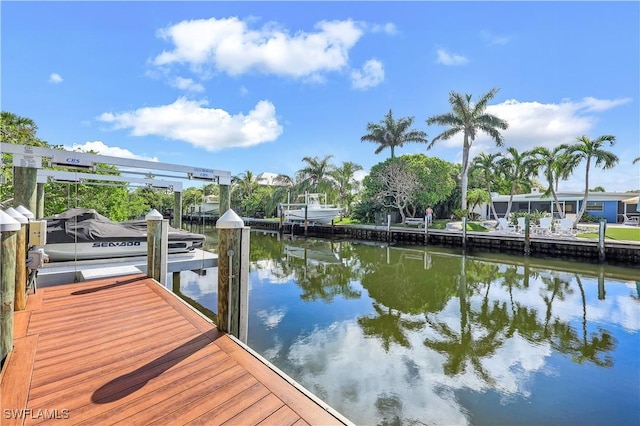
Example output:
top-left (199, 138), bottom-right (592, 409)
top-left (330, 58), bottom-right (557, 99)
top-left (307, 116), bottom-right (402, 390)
top-left (567, 135), bottom-right (619, 226)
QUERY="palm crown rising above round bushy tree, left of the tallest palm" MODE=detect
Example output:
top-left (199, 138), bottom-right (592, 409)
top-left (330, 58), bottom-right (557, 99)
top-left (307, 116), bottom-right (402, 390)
top-left (360, 110), bottom-right (428, 158)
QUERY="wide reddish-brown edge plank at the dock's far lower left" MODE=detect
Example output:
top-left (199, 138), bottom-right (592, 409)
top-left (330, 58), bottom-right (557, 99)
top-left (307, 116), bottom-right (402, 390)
top-left (0, 335), bottom-right (38, 425)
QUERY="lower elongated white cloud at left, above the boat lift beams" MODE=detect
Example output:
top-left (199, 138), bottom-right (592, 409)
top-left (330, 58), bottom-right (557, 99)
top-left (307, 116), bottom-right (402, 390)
top-left (98, 98), bottom-right (282, 151)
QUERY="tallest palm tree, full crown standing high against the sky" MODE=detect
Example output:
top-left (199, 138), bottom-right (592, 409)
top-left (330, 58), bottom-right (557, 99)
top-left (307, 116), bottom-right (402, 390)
top-left (427, 88), bottom-right (509, 209)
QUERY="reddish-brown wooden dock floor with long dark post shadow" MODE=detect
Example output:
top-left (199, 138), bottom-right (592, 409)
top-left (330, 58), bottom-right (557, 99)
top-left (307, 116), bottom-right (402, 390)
top-left (0, 274), bottom-right (349, 425)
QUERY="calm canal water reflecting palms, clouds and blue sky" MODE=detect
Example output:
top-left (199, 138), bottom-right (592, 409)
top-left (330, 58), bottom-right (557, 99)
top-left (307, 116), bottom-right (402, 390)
top-left (172, 232), bottom-right (640, 425)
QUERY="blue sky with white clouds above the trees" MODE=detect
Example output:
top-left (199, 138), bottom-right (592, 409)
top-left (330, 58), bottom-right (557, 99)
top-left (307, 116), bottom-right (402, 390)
top-left (0, 1), bottom-right (640, 191)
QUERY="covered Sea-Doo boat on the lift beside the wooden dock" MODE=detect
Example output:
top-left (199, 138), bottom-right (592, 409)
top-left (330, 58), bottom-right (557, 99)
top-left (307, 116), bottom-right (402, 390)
top-left (43, 208), bottom-right (205, 261)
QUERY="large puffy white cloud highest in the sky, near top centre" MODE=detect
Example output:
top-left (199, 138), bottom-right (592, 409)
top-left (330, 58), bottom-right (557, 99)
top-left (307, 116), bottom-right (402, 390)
top-left (153, 17), bottom-right (363, 78)
